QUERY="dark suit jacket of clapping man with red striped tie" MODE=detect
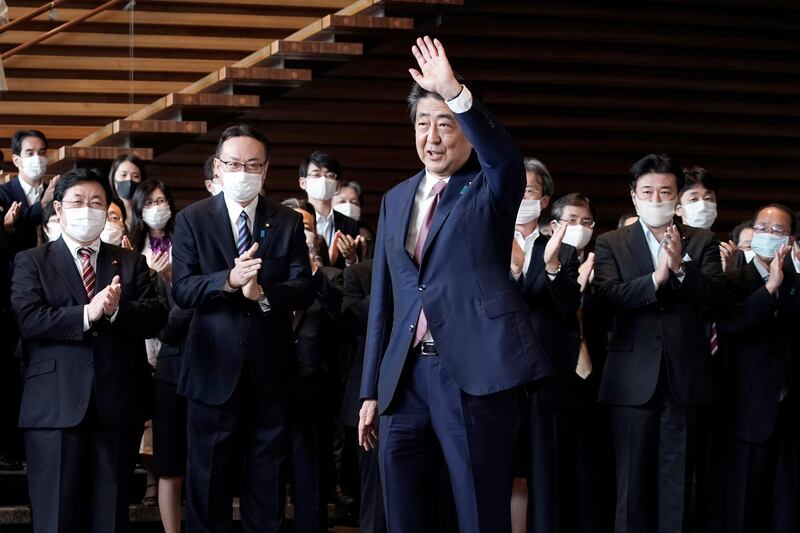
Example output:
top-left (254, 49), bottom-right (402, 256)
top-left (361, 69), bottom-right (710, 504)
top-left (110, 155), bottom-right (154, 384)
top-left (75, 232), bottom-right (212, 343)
top-left (12, 239), bottom-right (167, 428)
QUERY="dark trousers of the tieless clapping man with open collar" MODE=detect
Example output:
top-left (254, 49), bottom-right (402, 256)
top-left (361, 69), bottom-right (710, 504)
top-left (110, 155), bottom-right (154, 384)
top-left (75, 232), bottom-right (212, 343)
top-left (611, 370), bottom-right (700, 533)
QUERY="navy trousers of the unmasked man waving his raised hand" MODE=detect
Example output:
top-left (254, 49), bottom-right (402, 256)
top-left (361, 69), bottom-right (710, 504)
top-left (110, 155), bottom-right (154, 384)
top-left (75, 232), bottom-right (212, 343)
top-left (378, 353), bottom-right (520, 533)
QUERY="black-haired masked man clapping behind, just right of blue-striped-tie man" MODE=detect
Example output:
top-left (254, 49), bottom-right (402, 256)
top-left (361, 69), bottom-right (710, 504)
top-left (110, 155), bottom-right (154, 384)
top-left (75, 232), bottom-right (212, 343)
top-left (299, 151), bottom-right (361, 269)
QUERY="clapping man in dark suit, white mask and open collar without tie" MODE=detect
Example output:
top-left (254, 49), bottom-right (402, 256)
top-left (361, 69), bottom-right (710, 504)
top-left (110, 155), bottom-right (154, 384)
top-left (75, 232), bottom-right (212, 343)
top-left (594, 154), bottom-right (725, 533)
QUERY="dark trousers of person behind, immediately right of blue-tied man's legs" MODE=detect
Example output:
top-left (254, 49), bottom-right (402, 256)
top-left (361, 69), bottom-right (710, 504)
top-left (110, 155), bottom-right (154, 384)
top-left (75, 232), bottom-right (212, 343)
top-left (288, 378), bottom-right (327, 533)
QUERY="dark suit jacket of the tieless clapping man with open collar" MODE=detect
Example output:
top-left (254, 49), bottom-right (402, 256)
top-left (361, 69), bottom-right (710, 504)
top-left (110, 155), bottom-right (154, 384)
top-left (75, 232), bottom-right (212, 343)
top-left (594, 223), bottom-right (725, 405)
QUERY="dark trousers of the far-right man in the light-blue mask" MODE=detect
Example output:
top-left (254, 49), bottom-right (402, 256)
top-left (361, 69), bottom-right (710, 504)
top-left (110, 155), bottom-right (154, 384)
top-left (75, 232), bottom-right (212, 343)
top-left (717, 395), bottom-right (800, 533)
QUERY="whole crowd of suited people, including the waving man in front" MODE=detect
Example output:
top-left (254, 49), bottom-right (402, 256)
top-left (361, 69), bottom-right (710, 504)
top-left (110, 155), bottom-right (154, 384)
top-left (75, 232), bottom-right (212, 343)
top-left (0, 37), bottom-right (800, 533)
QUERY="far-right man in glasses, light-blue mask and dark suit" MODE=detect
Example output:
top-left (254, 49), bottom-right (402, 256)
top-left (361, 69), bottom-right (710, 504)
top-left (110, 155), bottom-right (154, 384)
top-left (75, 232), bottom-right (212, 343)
top-left (715, 204), bottom-right (800, 533)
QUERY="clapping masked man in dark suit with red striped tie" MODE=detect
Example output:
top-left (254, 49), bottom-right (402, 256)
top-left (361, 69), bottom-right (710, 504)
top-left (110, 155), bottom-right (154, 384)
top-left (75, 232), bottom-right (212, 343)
top-left (12, 169), bottom-right (167, 533)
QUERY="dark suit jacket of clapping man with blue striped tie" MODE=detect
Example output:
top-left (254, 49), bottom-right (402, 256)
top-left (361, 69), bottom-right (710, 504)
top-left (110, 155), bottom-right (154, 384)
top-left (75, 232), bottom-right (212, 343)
top-left (172, 193), bottom-right (314, 405)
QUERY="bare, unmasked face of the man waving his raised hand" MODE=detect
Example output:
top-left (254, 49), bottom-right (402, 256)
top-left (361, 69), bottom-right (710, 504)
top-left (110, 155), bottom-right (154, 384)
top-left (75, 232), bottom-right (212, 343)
top-left (414, 96), bottom-right (472, 179)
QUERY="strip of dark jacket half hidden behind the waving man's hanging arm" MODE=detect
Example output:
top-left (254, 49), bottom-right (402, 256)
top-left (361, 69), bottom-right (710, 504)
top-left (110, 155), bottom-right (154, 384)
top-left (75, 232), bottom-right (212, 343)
top-left (339, 259), bottom-right (372, 427)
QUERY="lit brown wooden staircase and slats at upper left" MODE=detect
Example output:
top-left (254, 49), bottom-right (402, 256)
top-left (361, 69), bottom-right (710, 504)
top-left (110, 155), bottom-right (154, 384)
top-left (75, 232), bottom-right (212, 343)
top-left (0, 0), bottom-right (461, 185)
